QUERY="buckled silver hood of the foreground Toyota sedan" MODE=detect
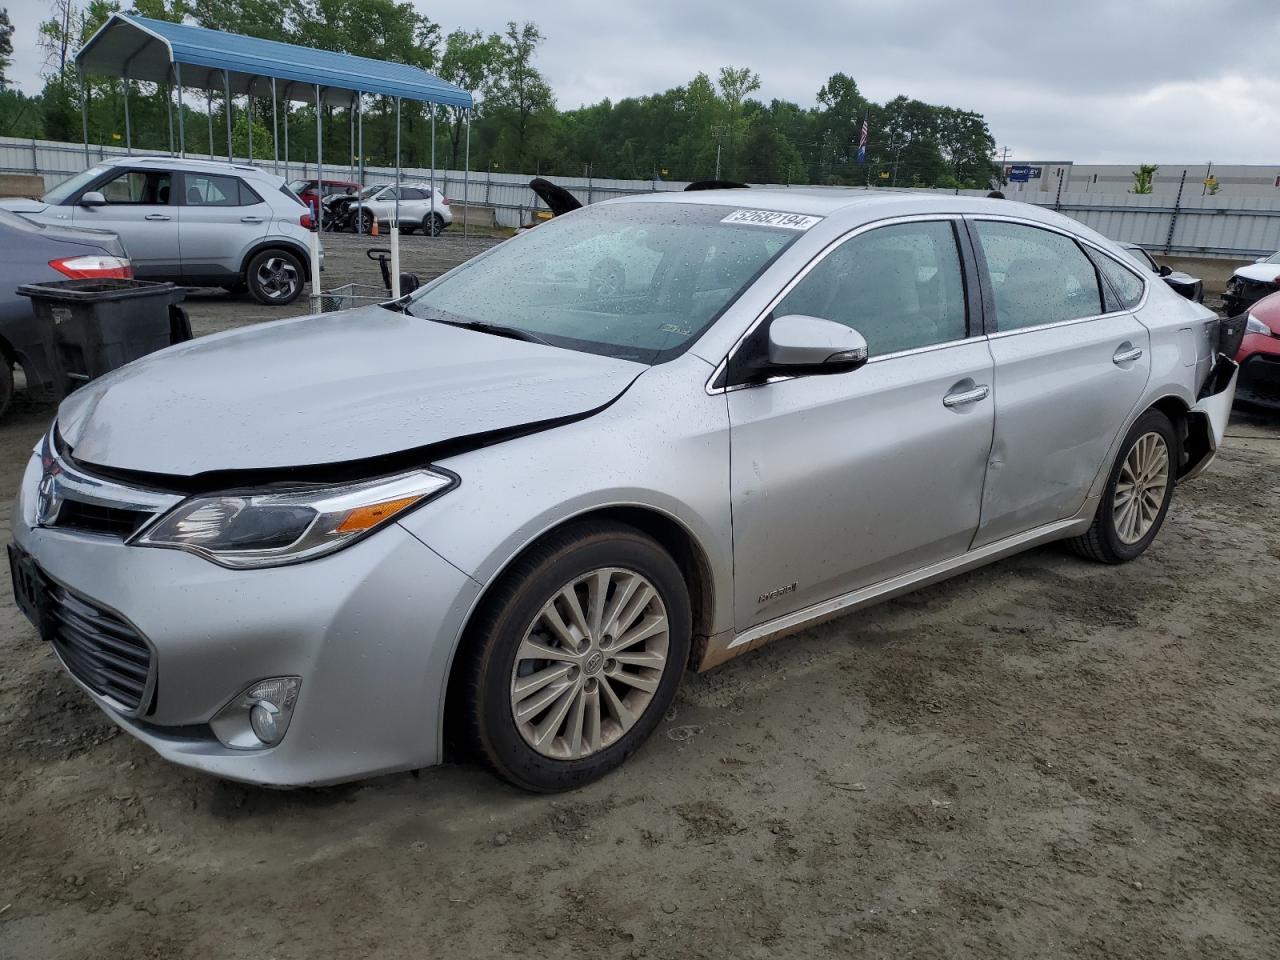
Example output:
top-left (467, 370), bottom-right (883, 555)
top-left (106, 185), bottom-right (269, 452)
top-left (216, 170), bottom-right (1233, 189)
top-left (58, 306), bottom-right (646, 477)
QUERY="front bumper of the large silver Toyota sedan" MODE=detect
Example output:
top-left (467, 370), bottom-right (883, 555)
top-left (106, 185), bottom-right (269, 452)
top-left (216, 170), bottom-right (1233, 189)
top-left (14, 457), bottom-right (480, 786)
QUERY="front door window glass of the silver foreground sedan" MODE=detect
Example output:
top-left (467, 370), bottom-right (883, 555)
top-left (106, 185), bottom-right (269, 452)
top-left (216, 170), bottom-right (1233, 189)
top-left (773, 220), bottom-right (968, 357)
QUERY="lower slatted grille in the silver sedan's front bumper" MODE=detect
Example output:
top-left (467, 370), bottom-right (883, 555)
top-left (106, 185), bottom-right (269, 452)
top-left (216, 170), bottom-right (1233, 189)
top-left (44, 577), bottom-right (151, 713)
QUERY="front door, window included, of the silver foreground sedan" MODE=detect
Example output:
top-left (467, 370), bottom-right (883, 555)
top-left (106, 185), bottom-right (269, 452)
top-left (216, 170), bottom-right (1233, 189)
top-left (727, 219), bottom-right (995, 630)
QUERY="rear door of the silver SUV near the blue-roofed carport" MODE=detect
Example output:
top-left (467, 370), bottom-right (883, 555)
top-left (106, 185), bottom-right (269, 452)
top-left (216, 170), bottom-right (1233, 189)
top-left (179, 172), bottom-right (271, 283)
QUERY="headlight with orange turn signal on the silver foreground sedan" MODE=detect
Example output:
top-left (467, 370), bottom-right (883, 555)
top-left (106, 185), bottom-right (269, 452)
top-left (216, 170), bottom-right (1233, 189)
top-left (129, 470), bottom-right (454, 568)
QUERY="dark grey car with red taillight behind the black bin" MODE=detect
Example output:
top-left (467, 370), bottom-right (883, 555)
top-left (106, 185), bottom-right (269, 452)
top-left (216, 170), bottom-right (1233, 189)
top-left (0, 210), bottom-right (133, 417)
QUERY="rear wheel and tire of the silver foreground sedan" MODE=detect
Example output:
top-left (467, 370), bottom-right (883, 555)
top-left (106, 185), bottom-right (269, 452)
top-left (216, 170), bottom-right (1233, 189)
top-left (1068, 410), bottom-right (1180, 563)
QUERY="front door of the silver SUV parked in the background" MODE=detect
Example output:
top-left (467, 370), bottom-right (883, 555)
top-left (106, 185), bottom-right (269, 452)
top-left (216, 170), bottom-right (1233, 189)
top-left (70, 168), bottom-right (182, 280)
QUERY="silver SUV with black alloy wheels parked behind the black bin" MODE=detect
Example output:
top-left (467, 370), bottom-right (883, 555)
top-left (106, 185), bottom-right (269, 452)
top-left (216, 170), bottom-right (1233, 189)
top-left (0, 156), bottom-right (314, 306)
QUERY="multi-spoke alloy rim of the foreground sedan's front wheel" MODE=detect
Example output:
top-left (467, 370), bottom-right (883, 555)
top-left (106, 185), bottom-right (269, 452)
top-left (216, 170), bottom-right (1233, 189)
top-left (511, 567), bottom-right (669, 760)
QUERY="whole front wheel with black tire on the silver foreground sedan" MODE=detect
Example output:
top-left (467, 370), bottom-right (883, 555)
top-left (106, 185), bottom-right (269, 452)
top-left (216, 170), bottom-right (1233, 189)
top-left (461, 522), bottom-right (692, 792)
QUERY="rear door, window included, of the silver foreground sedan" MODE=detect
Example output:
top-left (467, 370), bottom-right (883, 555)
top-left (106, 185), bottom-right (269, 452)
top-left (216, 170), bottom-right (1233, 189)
top-left (970, 218), bottom-right (1151, 547)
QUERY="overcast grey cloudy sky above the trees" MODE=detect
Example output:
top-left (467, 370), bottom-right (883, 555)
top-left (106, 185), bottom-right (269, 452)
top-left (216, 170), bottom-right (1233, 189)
top-left (10, 0), bottom-right (1280, 164)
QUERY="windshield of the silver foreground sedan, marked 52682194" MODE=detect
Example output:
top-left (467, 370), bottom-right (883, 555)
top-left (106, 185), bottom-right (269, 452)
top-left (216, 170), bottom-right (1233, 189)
top-left (408, 204), bottom-right (800, 364)
